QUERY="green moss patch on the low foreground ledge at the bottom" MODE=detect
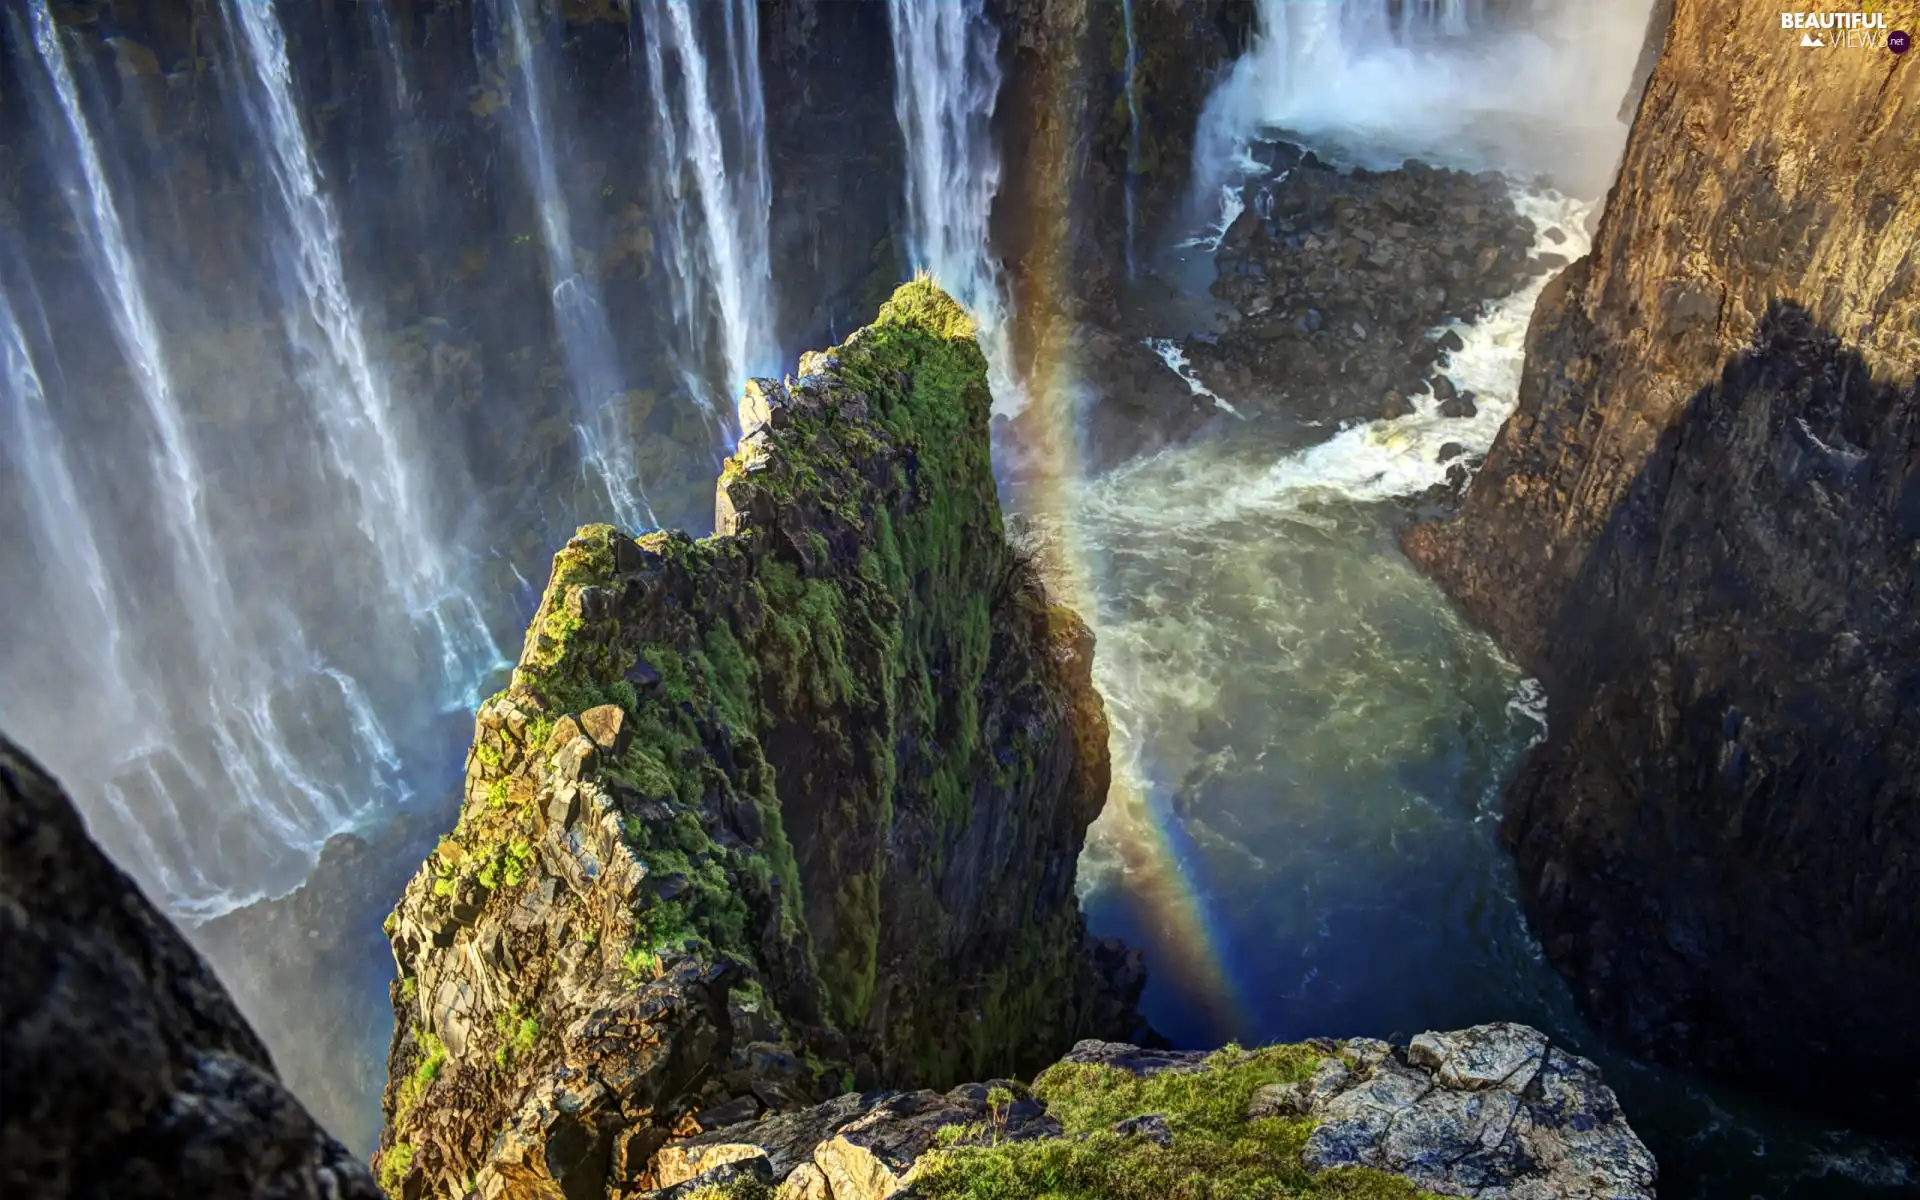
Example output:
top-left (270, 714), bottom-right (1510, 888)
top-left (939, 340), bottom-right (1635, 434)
top-left (916, 1046), bottom-right (1423, 1200)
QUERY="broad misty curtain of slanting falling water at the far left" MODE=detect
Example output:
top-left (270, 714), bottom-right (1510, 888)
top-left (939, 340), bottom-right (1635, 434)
top-left (0, 0), bottom-right (499, 916)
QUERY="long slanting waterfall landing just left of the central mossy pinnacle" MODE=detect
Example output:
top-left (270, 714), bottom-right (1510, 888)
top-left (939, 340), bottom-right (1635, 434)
top-left (228, 0), bottom-right (505, 708)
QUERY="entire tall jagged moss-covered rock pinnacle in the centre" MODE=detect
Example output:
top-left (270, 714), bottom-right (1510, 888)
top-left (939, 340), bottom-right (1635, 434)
top-left (380, 280), bottom-right (1140, 1198)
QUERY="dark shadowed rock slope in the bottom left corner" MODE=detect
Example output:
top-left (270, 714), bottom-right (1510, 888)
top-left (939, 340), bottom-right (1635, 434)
top-left (0, 737), bottom-right (380, 1200)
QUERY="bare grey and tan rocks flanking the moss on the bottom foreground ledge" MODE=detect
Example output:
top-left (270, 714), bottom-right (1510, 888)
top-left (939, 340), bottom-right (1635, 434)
top-left (645, 1021), bottom-right (1657, 1200)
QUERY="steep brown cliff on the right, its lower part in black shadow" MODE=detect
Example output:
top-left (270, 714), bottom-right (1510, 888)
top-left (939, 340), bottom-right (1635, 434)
top-left (1407, 0), bottom-right (1920, 1129)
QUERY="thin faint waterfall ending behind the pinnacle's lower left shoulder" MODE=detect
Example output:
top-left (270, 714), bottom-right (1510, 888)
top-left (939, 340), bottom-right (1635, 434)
top-left (499, 0), bottom-right (659, 532)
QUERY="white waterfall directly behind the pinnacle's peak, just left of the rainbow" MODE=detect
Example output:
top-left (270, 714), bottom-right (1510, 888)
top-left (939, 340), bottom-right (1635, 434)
top-left (887, 0), bottom-right (1025, 415)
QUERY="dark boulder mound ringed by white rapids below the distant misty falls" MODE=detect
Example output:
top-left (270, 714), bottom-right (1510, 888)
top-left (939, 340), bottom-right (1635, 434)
top-left (1187, 144), bottom-right (1567, 420)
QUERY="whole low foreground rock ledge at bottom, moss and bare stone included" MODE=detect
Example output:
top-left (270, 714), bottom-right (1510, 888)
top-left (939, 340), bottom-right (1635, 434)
top-left (629, 1023), bottom-right (1655, 1200)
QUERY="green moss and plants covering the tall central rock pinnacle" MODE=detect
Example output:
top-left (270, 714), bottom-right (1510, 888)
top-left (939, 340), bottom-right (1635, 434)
top-left (392, 278), bottom-right (1098, 1152)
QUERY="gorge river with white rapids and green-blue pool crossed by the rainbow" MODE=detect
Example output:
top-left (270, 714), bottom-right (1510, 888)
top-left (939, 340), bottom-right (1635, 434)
top-left (1062, 0), bottom-right (1920, 1198)
